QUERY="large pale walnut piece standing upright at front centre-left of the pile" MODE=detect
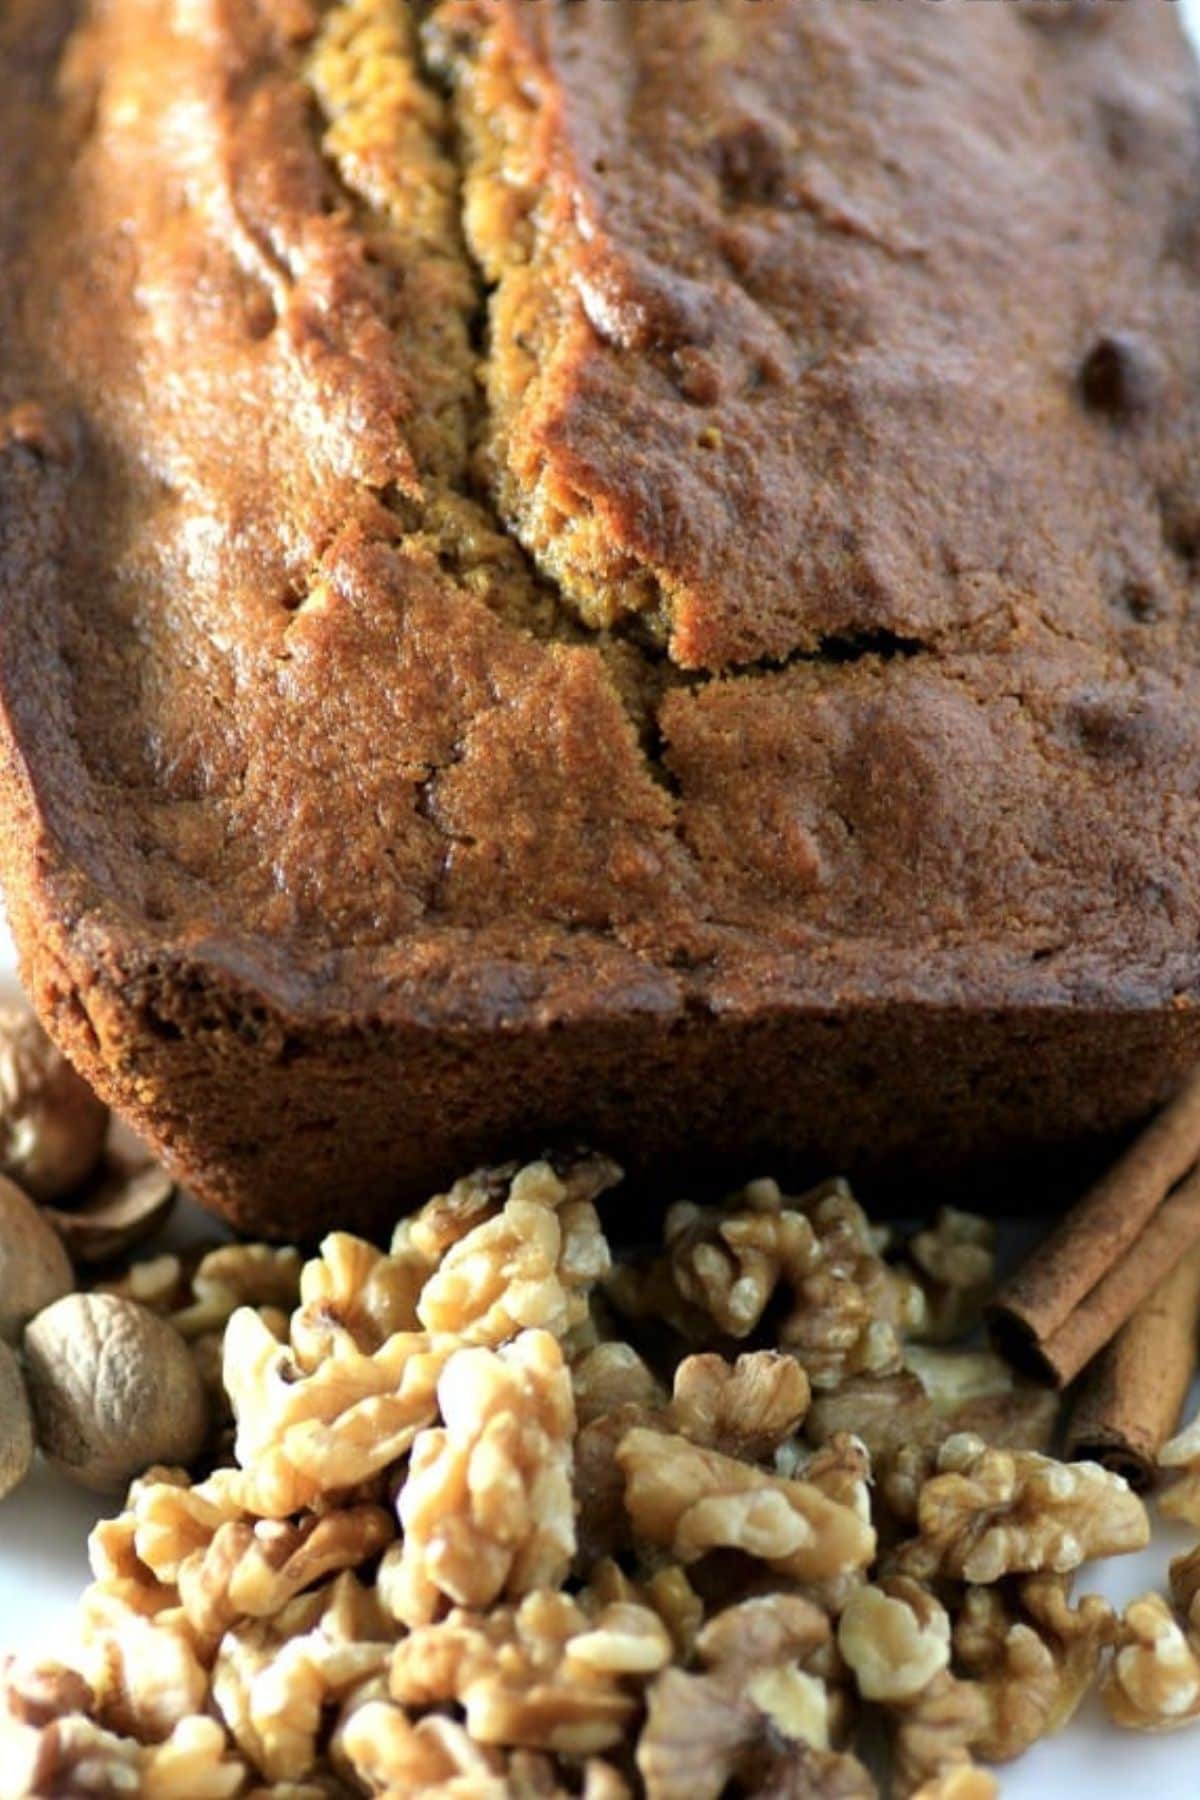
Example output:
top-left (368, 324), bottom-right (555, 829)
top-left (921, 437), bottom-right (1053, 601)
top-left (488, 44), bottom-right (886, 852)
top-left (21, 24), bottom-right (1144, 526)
top-left (389, 1330), bottom-right (576, 1625)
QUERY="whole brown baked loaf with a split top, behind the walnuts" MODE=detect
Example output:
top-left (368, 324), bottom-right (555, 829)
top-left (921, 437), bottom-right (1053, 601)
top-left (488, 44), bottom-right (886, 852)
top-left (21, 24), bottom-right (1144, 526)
top-left (0, 0), bottom-right (1200, 1235)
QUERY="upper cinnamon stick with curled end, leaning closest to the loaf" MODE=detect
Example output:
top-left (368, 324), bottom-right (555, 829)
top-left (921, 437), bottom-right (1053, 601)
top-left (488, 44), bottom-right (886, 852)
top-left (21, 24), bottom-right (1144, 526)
top-left (990, 1069), bottom-right (1200, 1384)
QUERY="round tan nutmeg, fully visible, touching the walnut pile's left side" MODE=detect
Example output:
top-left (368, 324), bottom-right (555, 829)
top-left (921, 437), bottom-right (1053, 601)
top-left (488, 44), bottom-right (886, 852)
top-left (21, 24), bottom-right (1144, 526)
top-left (25, 1294), bottom-right (209, 1494)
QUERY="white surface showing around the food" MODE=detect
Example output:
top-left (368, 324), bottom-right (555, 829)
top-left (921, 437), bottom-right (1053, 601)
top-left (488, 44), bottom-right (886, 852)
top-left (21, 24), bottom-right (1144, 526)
top-left (0, 0), bottom-right (1200, 1800)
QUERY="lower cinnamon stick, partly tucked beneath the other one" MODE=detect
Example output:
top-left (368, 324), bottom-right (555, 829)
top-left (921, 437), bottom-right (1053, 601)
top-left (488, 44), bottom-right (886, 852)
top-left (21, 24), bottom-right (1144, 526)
top-left (1065, 1244), bottom-right (1200, 1490)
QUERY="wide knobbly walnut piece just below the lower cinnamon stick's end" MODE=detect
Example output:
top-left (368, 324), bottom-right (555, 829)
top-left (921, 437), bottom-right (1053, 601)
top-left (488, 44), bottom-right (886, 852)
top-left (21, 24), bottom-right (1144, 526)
top-left (898, 1433), bottom-right (1150, 1582)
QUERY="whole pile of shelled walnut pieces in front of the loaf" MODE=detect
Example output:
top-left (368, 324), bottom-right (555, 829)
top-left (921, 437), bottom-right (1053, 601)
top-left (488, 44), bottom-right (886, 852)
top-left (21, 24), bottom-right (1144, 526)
top-left (0, 1159), bottom-right (1165, 1800)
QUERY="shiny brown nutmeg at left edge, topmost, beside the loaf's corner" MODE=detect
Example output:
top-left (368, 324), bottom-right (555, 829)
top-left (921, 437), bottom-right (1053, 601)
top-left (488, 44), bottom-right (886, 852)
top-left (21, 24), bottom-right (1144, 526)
top-left (0, 1006), bottom-right (108, 1201)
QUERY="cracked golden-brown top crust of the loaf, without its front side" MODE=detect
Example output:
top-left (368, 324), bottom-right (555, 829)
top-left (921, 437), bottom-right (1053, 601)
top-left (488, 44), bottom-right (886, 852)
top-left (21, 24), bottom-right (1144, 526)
top-left (2, 0), bottom-right (1200, 961)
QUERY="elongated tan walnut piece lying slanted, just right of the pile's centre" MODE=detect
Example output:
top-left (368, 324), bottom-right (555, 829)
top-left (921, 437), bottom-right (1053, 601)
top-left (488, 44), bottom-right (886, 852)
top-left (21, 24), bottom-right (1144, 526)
top-left (617, 1427), bottom-right (874, 1580)
